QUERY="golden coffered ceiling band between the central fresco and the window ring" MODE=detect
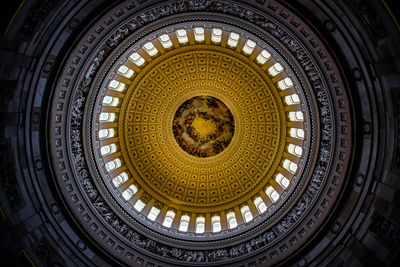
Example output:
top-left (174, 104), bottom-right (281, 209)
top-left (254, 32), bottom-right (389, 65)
top-left (118, 45), bottom-right (286, 212)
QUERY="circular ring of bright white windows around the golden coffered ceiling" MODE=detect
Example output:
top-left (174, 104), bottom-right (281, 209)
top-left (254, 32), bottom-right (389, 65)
top-left (94, 23), bottom-right (309, 238)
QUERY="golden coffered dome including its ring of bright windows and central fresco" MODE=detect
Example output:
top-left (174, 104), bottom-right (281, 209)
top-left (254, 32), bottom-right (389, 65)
top-left (88, 22), bottom-right (311, 238)
